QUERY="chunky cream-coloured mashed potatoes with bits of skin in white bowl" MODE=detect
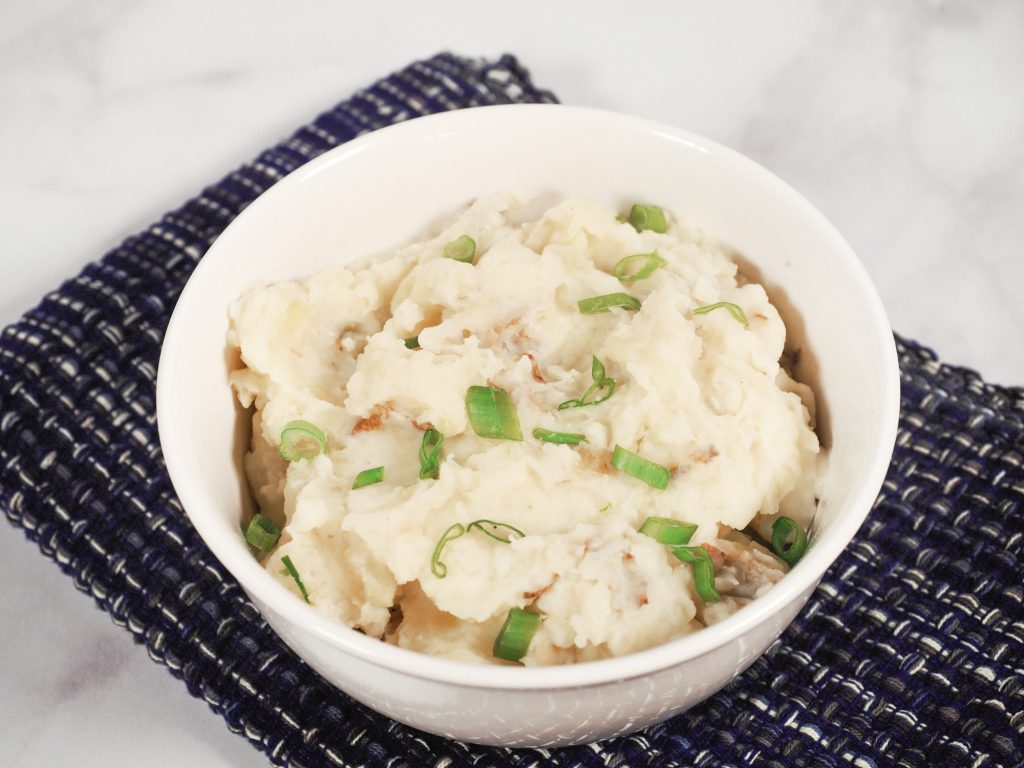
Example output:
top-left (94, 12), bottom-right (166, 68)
top-left (229, 198), bottom-right (819, 665)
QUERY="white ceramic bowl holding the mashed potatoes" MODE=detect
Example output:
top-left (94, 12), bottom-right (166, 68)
top-left (157, 105), bottom-right (899, 745)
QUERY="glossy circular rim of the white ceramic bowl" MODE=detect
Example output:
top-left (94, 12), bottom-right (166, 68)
top-left (157, 104), bottom-right (900, 690)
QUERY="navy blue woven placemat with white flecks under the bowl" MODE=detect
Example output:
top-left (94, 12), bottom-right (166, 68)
top-left (0, 54), bottom-right (1024, 768)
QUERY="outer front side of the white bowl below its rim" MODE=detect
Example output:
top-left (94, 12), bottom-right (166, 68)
top-left (245, 585), bottom-right (816, 748)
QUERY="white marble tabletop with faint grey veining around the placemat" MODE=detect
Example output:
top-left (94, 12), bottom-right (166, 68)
top-left (0, 0), bottom-right (1024, 768)
